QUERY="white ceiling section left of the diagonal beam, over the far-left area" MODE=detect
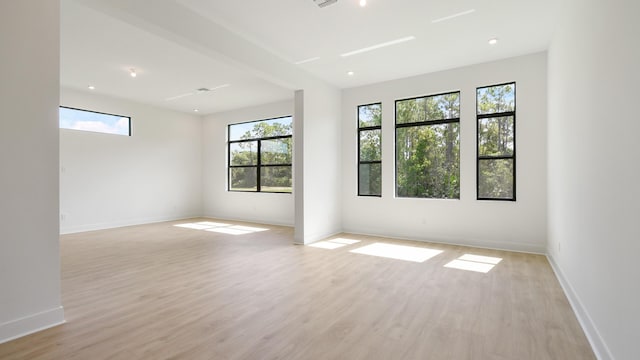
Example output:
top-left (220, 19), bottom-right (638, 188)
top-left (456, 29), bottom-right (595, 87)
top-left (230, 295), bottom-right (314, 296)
top-left (60, 1), bottom-right (292, 114)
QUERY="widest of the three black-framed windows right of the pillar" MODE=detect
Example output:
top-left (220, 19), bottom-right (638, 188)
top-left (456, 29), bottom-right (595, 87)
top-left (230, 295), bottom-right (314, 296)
top-left (395, 91), bottom-right (460, 199)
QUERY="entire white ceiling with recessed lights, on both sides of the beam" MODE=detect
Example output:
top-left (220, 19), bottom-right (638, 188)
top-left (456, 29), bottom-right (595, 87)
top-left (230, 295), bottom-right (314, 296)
top-left (61, 0), bottom-right (555, 114)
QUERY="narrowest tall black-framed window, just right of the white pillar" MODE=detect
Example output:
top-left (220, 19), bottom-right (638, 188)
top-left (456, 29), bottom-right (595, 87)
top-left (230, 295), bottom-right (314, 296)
top-left (358, 103), bottom-right (382, 196)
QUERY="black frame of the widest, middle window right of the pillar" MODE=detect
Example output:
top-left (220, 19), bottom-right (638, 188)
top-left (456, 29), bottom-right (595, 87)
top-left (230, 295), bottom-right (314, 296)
top-left (393, 90), bottom-right (462, 200)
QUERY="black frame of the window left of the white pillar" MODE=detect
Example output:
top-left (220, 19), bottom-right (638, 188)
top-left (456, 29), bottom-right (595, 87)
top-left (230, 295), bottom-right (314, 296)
top-left (227, 115), bottom-right (293, 194)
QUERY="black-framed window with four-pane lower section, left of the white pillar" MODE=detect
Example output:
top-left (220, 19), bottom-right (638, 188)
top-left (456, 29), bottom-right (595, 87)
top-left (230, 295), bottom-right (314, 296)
top-left (227, 116), bottom-right (293, 193)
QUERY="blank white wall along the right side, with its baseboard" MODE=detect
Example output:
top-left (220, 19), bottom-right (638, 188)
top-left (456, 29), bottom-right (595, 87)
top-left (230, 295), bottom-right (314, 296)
top-left (548, 0), bottom-right (640, 359)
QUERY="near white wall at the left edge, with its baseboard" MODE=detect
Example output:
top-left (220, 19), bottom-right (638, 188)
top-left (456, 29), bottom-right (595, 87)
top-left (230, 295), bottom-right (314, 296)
top-left (0, 0), bottom-right (64, 343)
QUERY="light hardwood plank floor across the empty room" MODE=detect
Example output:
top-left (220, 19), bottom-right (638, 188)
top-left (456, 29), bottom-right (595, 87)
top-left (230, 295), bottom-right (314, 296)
top-left (0, 219), bottom-right (595, 360)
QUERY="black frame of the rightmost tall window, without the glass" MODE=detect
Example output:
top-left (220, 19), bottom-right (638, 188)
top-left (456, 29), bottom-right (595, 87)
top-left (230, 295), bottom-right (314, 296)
top-left (475, 81), bottom-right (518, 202)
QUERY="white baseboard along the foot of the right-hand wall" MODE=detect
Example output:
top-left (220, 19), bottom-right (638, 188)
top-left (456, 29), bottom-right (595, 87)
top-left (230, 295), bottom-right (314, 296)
top-left (547, 255), bottom-right (614, 360)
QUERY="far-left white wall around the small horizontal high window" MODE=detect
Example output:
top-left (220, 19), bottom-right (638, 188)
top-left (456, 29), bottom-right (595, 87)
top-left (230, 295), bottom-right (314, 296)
top-left (60, 89), bottom-right (202, 233)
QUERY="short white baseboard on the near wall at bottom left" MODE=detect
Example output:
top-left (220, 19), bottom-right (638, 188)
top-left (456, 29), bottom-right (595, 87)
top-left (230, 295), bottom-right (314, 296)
top-left (0, 306), bottom-right (65, 344)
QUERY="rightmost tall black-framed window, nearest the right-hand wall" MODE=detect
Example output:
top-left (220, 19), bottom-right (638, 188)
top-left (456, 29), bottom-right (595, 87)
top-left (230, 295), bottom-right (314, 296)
top-left (476, 82), bottom-right (516, 201)
